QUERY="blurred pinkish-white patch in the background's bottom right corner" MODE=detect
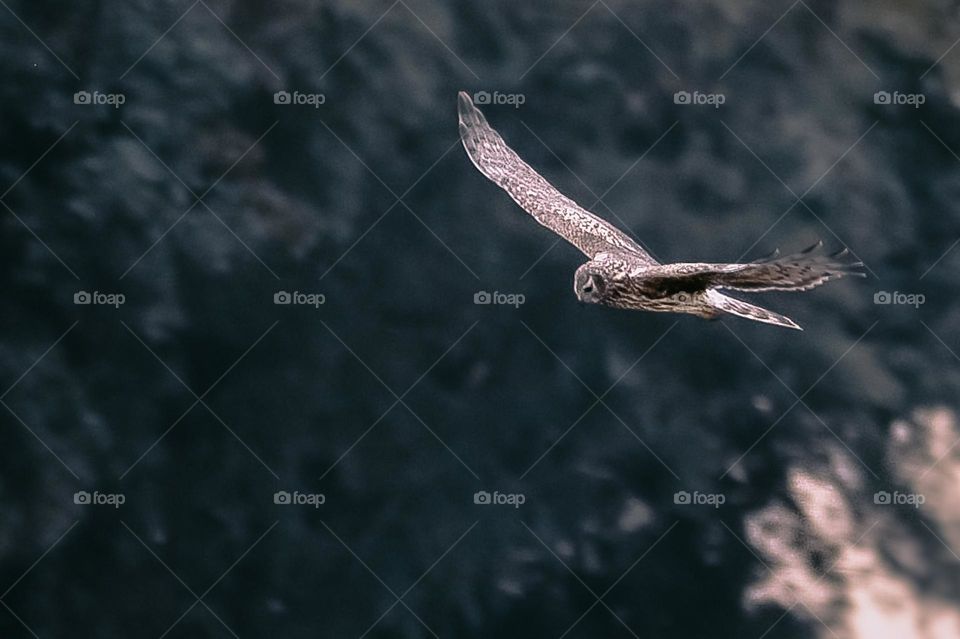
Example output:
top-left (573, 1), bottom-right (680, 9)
top-left (744, 408), bottom-right (960, 639)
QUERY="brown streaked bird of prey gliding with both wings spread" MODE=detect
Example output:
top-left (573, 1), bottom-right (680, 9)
top-left (457, 91), bottom-right (864, 330)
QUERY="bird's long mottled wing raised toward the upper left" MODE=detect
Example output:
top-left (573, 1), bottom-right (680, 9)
top-left (457, 91), bottom-right (657, 266)
